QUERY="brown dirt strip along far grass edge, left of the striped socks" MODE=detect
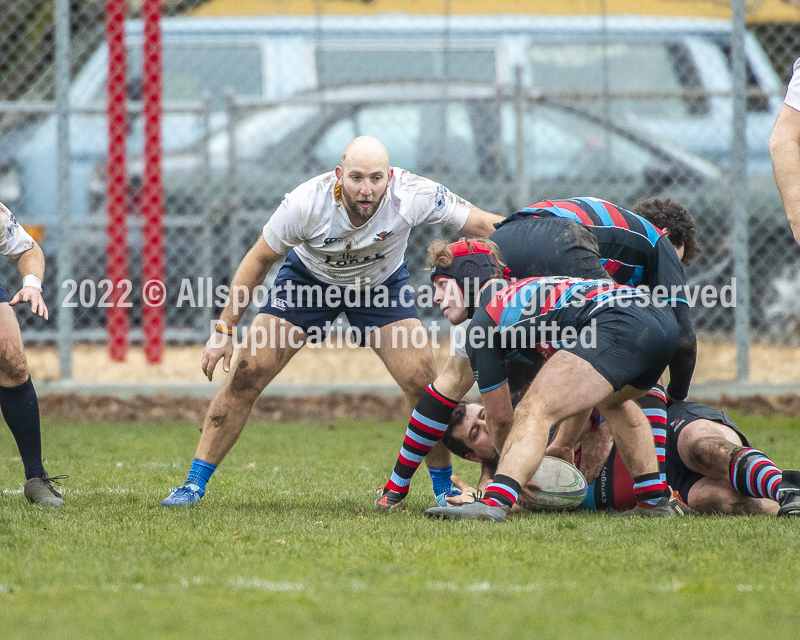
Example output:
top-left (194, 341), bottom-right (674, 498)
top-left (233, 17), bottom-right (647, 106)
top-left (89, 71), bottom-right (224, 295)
top-left (39, 393), bottom-right (408, 425)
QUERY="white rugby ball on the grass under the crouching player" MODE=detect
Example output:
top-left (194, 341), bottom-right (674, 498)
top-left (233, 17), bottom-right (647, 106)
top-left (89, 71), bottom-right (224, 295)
top-left (519, 456), bottom-right (588, 511)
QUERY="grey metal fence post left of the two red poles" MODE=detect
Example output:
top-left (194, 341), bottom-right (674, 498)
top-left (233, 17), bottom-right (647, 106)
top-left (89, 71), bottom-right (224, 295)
top-left (55, 0), bottom-right (72, 380)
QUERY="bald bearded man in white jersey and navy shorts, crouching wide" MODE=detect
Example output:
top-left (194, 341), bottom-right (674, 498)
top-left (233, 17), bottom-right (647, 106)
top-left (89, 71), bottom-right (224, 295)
top-left (162, 136), bottom-right (501, 507)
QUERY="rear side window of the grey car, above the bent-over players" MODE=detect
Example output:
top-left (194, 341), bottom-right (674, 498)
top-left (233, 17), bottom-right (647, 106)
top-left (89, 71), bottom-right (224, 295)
top-left (502, 104), bottom-right (656, 182)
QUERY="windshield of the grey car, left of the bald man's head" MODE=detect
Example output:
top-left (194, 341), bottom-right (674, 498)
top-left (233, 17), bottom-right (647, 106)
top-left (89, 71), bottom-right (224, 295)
top-left (208, 105), bottom-right (318, 160)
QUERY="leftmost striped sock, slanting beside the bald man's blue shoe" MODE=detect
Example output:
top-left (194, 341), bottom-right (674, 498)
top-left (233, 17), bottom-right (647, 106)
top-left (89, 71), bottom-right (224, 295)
top-left (384, 384), bottom-right (458, 494)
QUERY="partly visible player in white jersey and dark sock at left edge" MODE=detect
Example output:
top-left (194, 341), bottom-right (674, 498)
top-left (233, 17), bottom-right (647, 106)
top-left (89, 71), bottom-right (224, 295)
top-left (0, 203), bottom-right (67, 507)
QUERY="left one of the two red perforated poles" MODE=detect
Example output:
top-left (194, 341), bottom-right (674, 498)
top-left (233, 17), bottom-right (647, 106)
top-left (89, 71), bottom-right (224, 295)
top-left (106, 0), bottom-right (130, 362)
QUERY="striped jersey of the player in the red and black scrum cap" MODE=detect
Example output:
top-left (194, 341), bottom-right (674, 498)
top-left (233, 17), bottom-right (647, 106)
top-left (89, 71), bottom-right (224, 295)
top-left (466, 277), bottom-right (650, 393)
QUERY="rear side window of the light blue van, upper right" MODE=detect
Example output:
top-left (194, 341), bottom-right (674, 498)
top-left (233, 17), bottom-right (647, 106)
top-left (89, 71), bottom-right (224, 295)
top-left (528, 42), bottom-right (708, 118)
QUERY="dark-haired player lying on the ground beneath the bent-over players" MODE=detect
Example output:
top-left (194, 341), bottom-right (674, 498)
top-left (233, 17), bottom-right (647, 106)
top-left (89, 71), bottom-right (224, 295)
top-left (442, 387), bottom-right (800, 517)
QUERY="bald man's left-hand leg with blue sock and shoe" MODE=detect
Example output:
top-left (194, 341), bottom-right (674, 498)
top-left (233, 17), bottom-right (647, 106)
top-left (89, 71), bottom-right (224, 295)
top-left (161, 313), bottom-right (308, 507)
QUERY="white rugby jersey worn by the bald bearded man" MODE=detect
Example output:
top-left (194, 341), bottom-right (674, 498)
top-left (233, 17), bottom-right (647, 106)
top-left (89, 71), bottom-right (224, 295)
top-left (263, 167), bottom-right (472, 288)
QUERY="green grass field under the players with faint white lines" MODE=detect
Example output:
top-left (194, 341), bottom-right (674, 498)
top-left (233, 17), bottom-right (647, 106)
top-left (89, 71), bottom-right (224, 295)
top-left (0, 416), bottom-right (800, 640)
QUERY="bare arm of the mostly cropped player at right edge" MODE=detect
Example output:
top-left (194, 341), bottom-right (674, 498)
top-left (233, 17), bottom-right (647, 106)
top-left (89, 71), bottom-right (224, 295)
top-left (769, 104), bottom-right (800, 243)
